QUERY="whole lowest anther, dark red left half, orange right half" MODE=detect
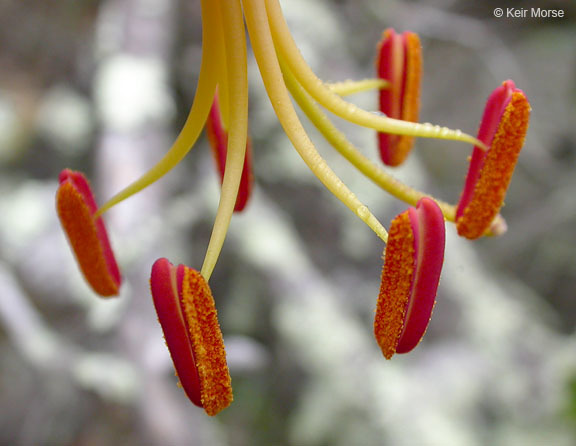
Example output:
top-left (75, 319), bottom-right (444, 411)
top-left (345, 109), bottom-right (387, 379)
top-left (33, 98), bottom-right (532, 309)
top-left (150, 259), bottom-right (233, 415)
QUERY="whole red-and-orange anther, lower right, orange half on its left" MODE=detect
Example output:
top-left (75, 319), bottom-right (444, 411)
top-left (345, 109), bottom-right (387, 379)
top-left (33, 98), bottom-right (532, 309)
top-left (374, 198), bottom-right (445, 359)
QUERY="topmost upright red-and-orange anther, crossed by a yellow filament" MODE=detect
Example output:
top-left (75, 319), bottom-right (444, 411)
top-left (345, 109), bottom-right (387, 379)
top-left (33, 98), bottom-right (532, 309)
top-left (376, 28), bottom-right (422, 166)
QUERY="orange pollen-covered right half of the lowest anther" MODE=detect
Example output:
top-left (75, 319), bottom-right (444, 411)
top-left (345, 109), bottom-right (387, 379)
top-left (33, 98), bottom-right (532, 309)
top-left (181, 268), bottom-right (233, 416)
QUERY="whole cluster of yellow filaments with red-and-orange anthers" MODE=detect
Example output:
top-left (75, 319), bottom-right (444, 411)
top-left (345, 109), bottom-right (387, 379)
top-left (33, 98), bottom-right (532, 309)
top-left (57, 0), bottom-right (527, 415)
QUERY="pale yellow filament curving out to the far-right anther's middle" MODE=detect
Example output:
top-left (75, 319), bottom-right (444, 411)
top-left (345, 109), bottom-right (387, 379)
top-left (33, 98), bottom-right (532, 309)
top-left (265, 0), bottom-right (486, 148)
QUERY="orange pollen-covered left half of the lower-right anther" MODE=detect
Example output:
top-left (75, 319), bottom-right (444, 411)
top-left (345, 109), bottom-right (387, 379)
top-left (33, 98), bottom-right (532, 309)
top-left (374, 212), bottom-right (415, 359)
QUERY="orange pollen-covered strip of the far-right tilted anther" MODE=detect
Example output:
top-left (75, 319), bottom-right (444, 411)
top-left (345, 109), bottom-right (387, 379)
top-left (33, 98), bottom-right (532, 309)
top-left (456, 91), bottom-right (530, 239)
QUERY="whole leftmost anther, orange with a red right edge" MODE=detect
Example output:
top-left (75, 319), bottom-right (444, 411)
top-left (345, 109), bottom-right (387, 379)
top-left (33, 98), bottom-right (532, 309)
top-left (56, 169), bottom-right (122, 297)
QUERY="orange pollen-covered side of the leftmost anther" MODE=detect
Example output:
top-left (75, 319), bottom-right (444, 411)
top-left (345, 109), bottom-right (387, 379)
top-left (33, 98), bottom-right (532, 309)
top-left (56, 181), bottom-right (120, 297)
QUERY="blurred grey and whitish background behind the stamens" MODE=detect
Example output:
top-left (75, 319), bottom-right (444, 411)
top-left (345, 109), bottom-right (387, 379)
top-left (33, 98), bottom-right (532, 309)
top-left (0, 0), bottom-right (576, 446)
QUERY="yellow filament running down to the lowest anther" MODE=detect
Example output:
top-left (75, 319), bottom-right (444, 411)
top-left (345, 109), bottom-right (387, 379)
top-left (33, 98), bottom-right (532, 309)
top-left (201, 0), bottom-right (248, 281)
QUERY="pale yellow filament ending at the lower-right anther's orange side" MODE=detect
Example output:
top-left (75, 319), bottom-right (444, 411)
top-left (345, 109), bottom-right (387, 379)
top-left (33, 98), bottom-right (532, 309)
top-left (243, 0), bottom-right (388, 241)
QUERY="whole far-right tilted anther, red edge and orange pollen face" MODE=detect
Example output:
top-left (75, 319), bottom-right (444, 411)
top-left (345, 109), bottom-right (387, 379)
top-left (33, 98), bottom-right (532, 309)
top-left (456, 80), bottom-right (530, 239)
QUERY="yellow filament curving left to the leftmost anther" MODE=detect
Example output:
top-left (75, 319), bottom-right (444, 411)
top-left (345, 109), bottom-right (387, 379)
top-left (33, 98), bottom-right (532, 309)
top-left (95, 0), bottom-right (223, 217)
